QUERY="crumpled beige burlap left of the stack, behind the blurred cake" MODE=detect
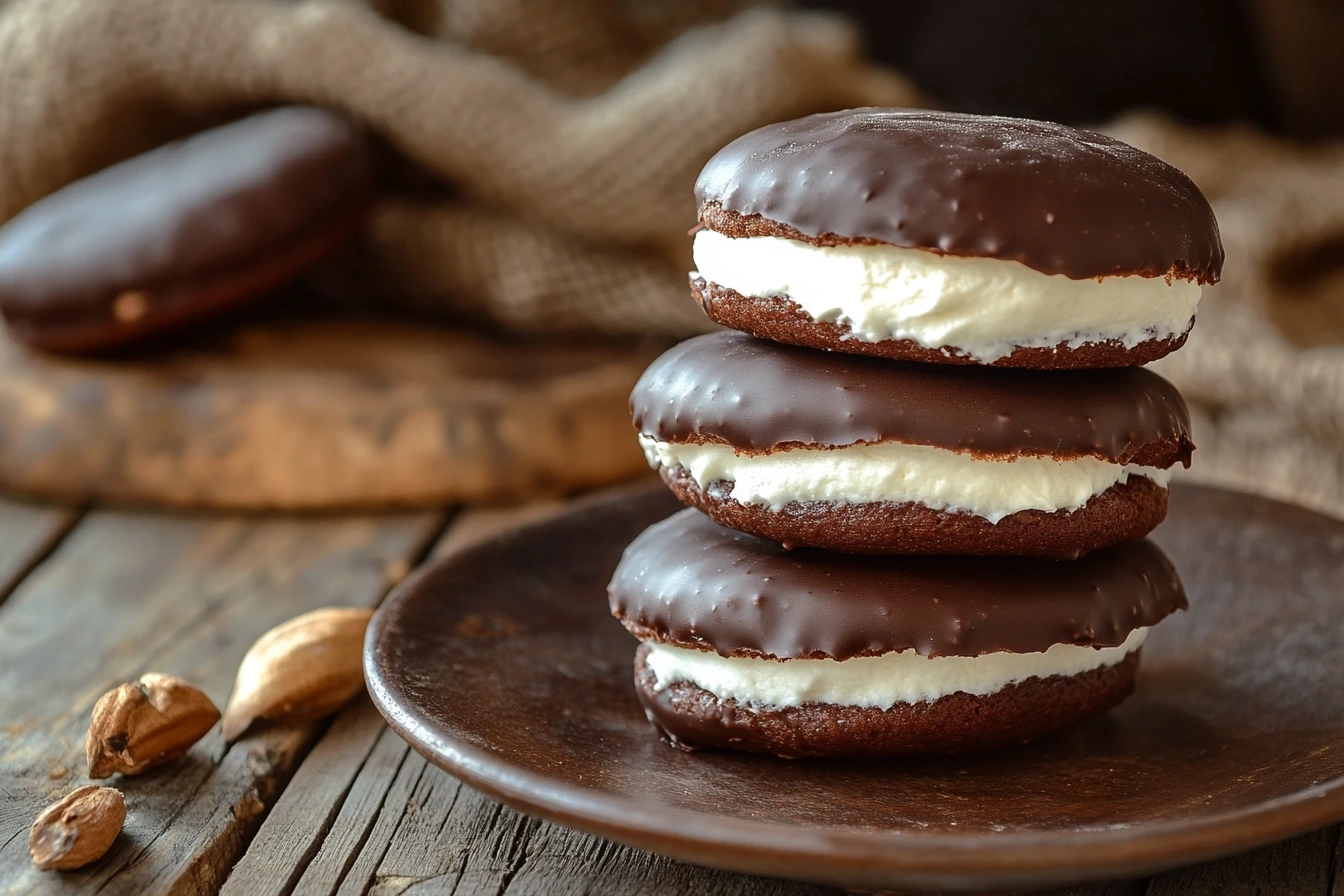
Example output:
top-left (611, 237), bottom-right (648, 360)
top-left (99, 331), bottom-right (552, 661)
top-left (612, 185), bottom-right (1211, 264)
top-left (0, 0), bottom-right (915, 334)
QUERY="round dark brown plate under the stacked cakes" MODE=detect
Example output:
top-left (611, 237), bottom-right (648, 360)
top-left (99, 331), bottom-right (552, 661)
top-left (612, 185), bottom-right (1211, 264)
top-left (364, 486), bottom-right (1344, 889)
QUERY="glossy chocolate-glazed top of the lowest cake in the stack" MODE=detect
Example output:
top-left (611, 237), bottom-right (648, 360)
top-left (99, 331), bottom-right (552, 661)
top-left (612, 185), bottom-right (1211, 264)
top-left (607, 509), bottom-right (1187, 660)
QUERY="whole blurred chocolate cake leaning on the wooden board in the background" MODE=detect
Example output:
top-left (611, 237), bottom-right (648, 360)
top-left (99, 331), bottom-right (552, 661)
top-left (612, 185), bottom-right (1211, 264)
top-left (0, 106), bottom-right (374, 352)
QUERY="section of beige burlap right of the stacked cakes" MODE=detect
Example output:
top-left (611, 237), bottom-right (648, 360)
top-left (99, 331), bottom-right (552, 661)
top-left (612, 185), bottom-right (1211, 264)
top-left (1105, 116), bottom-right (1344, 516)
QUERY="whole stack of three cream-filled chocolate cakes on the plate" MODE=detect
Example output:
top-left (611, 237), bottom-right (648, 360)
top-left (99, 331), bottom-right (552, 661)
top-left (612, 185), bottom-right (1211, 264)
top-left (610, 109), bottom-right (1223, 756)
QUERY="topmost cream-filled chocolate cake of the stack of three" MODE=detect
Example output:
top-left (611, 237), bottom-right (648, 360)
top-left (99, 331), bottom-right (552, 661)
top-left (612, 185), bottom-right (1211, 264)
top-left (691, 109), bottom-right (1223, 368)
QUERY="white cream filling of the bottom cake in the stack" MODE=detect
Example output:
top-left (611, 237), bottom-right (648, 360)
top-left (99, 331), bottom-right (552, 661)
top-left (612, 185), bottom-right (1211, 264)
top-left (645, 629), bottom-right (1148, 709)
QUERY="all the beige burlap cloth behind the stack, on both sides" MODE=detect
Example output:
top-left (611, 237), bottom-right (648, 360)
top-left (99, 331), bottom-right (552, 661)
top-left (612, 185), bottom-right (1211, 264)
top-left (0, 0), bottom-right (1344, 514)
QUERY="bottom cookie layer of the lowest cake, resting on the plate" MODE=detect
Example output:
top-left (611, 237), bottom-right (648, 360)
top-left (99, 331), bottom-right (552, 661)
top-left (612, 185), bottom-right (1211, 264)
top-left (634, 645), bottom-right (1142, 759)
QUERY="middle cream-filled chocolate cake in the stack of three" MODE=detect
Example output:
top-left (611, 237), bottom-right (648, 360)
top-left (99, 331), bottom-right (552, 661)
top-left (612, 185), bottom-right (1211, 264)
top-left (630, 332), bottom-right (1193, 557)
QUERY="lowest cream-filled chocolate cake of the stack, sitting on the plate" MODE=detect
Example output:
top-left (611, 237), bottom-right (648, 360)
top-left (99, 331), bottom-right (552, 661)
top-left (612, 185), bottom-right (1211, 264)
top-left (609, 509), bottom-right (1187, 758)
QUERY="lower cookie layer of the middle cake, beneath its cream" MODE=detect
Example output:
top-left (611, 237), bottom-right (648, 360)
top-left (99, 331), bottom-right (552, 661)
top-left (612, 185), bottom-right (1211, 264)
top-left (659, 466), bottom-right (1168, 560)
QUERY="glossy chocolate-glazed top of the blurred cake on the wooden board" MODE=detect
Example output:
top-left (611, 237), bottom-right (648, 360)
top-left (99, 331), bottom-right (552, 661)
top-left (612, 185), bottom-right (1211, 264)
top-left (0, 106), bottom-right (372, 316)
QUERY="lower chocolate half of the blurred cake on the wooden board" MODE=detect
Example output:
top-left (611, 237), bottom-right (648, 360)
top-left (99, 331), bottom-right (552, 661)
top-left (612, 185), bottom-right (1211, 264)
top-left (3, 201), bottom-right (370, 355)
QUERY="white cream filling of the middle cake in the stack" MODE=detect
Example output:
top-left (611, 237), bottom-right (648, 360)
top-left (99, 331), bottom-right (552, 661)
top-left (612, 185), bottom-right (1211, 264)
top-left (640, 435), bottom-right (1171, 523)
